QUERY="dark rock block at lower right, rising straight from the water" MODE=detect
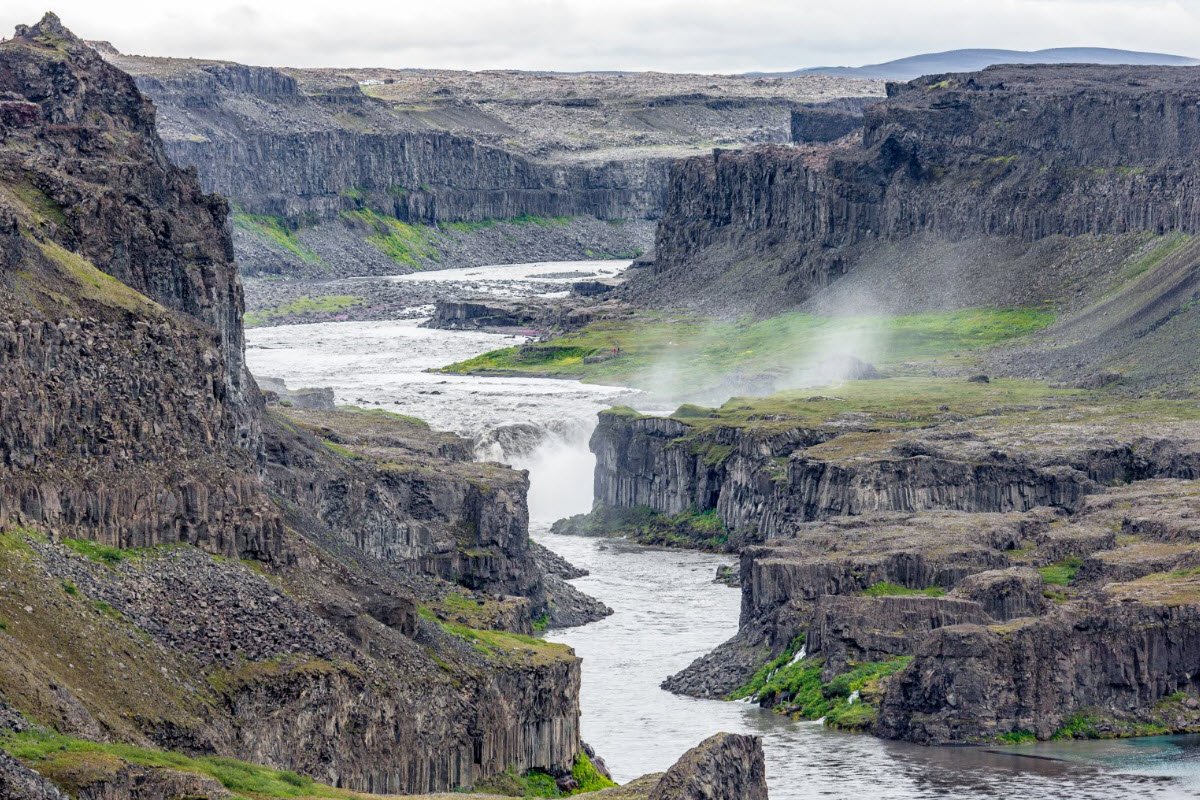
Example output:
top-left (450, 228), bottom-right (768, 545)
top-left (878, 594), bottom-right (1200, 744)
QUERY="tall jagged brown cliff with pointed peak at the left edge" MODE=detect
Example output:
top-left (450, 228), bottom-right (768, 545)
top-left (0, 17), bottom-right (284, 559)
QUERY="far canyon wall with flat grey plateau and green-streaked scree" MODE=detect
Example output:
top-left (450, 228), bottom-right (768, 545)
top-left (96, 43), bottom-right (882, 278)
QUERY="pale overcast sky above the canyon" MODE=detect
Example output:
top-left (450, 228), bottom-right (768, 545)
top-left (0, 0), bottom-right (1200, 72)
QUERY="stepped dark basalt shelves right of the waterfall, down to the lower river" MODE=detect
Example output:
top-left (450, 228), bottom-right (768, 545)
top-left (593, 378), bottom-right (1200, 744)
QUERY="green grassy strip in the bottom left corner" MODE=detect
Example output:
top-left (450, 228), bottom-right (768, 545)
top-left (0, 729), bottom-right (359, 800)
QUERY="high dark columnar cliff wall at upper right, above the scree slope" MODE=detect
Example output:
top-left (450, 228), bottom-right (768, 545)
top-left (634, 66), bottom-right (1200, 319)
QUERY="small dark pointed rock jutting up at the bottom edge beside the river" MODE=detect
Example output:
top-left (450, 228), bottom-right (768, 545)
top-left (649, 733), bottom-right (767, 800)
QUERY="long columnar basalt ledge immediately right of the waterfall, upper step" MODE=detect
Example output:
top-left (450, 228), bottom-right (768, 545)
top-left (592, 409), bottom-right (1200, 539)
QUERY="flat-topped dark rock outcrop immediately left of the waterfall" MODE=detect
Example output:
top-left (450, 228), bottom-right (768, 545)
top-left (266, 410), bottom-right (548, 627)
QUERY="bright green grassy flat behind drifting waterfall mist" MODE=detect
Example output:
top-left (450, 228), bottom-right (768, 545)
top-left (444, 308), bottom-right (1054, 395)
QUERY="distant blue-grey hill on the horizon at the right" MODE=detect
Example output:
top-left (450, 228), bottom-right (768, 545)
top-left (750, 47), bottom-right (1200, 80)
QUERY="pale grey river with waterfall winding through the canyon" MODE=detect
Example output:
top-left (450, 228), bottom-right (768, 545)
top-left (246, 263), bottom-right (1200, 800)
